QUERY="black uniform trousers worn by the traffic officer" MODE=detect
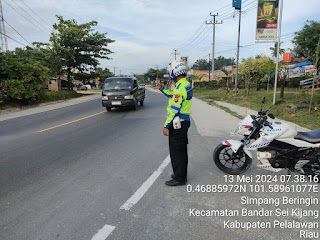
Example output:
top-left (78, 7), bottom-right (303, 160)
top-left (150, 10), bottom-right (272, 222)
top-left (169, 121), bottom-right (190, 182)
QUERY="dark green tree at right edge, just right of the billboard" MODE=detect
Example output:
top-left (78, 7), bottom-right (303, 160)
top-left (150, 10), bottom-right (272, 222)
top-left (292, 21), bottom-right (320, 62)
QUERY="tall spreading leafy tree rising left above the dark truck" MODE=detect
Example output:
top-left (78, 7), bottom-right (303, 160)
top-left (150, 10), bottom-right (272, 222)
top-left (50, 15), bottom-right (114, 89)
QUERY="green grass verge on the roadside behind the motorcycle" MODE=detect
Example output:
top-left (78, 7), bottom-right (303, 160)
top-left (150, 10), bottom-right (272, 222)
top-left (194, 88), bottom-right (320, 129)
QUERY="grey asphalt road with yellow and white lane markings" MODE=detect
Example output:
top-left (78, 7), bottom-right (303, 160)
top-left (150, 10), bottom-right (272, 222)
top-left (0, 91), bottom-right (319, 240)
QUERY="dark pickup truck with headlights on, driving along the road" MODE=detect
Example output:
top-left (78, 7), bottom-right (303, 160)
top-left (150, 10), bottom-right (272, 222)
top-left (102, 77), bottom-right (146, 111)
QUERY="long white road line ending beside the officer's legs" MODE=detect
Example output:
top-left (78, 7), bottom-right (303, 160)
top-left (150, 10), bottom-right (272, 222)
top-left (120, 155), bottom-right (170, 210)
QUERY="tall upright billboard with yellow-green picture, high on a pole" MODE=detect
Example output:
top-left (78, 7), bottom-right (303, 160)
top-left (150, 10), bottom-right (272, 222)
top-left (256, 0), bottom-right (279, 40)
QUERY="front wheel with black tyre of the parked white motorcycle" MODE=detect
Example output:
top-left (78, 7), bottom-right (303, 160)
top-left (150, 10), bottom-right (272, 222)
top-left (213, 143), bottom-right (252, 175)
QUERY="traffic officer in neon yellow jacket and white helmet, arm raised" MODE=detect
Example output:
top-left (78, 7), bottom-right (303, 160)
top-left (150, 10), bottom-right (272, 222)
top-left (158, 61), bottom-right (193, 186)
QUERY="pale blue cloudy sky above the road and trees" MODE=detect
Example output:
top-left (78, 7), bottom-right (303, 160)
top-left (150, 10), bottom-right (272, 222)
top-left (0, 0), bottom-right (320, 75)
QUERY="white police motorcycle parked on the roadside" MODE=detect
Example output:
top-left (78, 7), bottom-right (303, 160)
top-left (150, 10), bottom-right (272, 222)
top-left (213, 98), bottom-right (320, 176)
